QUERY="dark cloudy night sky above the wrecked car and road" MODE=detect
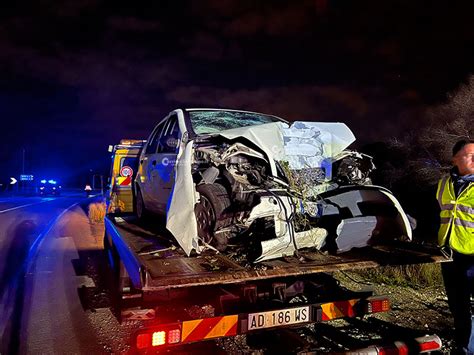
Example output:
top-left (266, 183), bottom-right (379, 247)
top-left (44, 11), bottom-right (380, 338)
top-left (0, 0), bottom-right (474, 184)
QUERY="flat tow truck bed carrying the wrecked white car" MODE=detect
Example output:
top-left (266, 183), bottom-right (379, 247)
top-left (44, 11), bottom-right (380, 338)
top-left (105, 216), bottom-right (445, 292)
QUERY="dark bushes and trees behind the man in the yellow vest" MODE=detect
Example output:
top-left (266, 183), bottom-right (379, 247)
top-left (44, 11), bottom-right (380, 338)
top-left (364, 76), bottom-right (474, 240)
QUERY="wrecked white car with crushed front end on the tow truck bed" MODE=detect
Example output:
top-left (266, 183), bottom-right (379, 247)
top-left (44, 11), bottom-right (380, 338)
top-left (134, 109), bottom-right (411, 262)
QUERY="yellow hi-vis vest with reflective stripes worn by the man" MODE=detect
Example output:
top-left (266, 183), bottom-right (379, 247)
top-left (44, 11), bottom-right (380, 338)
top-left (436, 176), bottom-right (474, 255)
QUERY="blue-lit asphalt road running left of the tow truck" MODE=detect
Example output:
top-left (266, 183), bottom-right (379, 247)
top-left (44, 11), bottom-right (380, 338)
top-left (0, 194), bottom-right (107, 354)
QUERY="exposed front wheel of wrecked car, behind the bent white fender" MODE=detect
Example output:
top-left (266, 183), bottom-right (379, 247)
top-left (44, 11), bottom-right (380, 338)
top-left (194, 184), bottom-right (232, 251)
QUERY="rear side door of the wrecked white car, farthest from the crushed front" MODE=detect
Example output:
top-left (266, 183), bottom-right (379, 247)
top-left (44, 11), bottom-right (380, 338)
top-left (138, 120), bottom-right (166, 213)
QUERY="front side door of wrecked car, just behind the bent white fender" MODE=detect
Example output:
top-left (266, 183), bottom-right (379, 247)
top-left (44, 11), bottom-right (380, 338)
top-left (152, 113), bottom-right (181, 215)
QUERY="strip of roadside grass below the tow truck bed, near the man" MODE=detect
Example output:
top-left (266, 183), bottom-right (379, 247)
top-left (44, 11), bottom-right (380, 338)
top-left (344, 263), bottom-right (443, 289)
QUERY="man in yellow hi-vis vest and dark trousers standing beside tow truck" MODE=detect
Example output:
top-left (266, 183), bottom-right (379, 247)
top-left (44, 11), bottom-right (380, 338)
top-left (436, 140), bottom-right (474, 354)
